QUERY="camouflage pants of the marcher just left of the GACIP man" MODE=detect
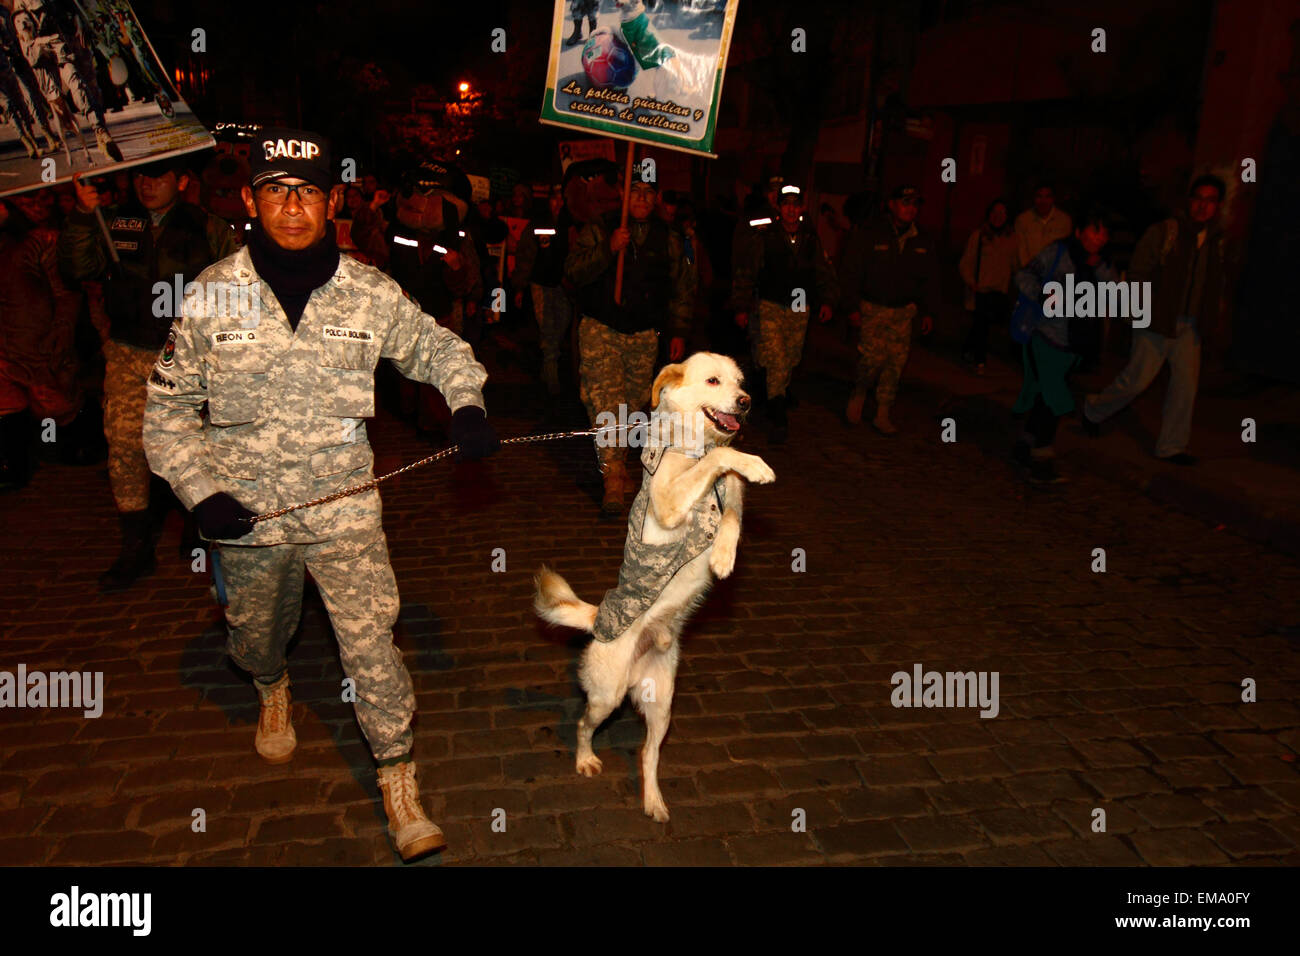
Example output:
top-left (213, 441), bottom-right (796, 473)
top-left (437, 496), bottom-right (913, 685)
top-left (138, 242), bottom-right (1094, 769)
top-left (104, 339), bottom-right (157, 514)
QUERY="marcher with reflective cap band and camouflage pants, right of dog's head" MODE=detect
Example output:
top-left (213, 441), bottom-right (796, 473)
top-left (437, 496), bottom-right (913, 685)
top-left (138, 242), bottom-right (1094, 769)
top-left (732, 186), bottom-right (837, 445)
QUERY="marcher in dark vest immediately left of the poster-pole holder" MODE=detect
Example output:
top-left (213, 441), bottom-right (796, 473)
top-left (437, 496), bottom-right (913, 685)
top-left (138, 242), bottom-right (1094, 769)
top-left (510, 186), bottom-right (573, 395)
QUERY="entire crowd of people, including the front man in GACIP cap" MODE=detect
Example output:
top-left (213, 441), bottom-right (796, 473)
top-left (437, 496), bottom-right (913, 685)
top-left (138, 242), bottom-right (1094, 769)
top-left (0, 121), bottom-right (1227, 858)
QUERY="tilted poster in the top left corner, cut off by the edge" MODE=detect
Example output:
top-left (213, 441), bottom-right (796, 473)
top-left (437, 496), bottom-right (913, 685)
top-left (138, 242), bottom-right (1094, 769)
top-left (0, 0), bottom-right (213, 195)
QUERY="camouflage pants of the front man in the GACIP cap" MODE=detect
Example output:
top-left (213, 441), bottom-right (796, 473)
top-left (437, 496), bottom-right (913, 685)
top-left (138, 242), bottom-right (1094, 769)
top-left (218, 528), bottom-right (415, 760)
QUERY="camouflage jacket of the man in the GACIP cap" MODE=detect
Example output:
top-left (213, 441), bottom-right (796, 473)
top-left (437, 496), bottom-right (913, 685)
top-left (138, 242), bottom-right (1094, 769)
top-left (143, 248), bottom-right (488, 545)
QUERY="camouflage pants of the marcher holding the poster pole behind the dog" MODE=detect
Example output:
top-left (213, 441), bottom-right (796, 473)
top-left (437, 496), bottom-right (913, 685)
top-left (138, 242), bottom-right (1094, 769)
top-left (577, 316), bottom-right (659, 468)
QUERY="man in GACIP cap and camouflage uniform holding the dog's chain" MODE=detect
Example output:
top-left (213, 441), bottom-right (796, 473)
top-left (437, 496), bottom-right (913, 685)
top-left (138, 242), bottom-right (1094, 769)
top-left (144, 129), bottom-right (498, 860)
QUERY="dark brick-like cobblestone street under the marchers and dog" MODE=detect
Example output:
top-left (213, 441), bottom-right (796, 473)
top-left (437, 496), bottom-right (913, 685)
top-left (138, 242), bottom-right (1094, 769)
top-left (0, 345), bottom-right (1300, 866)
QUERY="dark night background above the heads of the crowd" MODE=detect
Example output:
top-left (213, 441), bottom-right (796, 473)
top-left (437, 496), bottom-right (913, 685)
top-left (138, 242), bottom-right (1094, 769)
top-left (135, 0), bottom-right (1300, 381)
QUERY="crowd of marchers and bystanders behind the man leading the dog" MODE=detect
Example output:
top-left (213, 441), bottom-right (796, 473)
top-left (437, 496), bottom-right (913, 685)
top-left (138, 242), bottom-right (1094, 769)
top-left (0, 143), bottom-right (1227, 561)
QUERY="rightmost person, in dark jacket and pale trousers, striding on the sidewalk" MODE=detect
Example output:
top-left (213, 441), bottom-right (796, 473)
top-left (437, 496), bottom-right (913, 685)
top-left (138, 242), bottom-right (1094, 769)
top-left (1083, 176), bottom-right (1227, 464)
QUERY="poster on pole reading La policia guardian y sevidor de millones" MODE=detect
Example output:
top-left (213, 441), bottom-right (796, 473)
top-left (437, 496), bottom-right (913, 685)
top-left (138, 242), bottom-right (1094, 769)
top-left (541, 0), bottom-right (740, 157)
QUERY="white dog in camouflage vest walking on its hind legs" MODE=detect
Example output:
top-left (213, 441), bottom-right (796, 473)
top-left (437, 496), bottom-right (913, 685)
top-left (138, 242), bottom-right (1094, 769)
top-left (533, 352), bottom-right (776, 823)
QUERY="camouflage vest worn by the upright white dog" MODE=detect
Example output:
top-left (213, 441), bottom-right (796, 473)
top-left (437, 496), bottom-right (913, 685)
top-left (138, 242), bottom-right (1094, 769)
top-left (592, 445), bottom-right (727, 641)
